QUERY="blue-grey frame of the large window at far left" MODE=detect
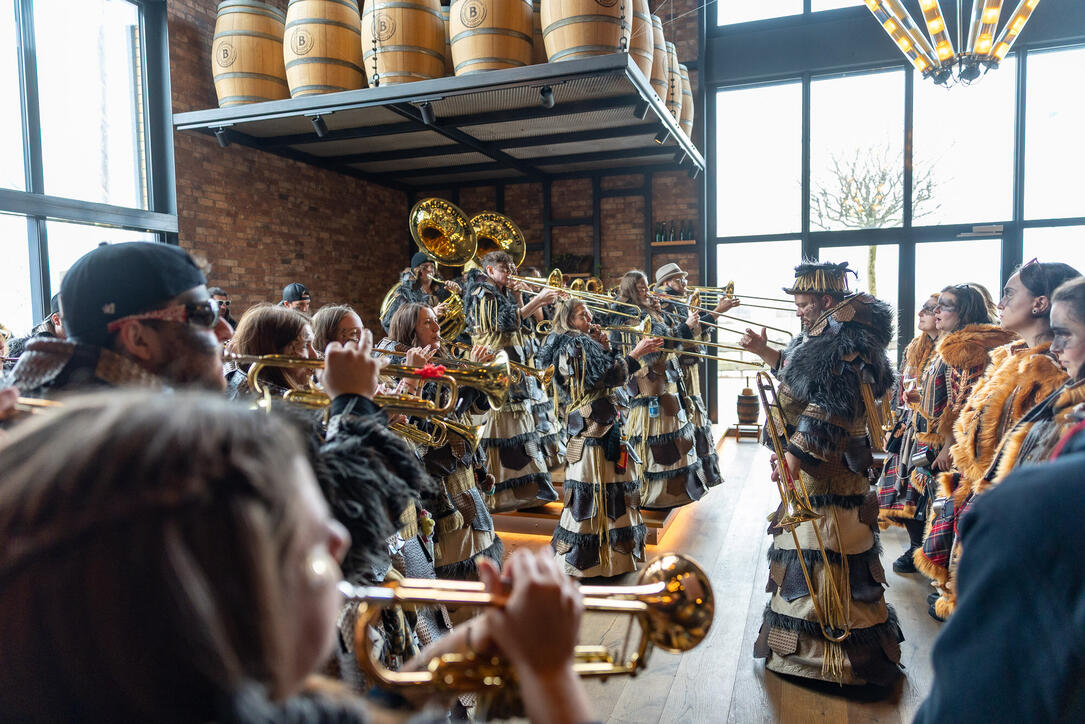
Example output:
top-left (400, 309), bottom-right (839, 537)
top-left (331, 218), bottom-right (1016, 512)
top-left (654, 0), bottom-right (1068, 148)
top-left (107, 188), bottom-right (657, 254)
top-left (0, 0), bottom-right (178, 319)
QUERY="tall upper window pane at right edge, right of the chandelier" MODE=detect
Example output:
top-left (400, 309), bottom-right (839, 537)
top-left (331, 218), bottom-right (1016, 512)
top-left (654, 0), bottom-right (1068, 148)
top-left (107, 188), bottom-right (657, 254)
top-left (1024, 48), bottom-right (1085, 218)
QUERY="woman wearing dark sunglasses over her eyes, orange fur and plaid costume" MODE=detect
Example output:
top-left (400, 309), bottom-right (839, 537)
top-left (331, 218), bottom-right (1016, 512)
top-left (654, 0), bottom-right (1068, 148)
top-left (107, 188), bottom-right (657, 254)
top-left (909, 284), bottom-right (1018, 618)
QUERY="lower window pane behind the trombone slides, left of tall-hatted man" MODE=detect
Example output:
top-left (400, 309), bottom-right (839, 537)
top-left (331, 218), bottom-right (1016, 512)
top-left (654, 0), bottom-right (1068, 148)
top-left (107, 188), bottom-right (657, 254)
top-left (716, 239), bottom-right (803, 429)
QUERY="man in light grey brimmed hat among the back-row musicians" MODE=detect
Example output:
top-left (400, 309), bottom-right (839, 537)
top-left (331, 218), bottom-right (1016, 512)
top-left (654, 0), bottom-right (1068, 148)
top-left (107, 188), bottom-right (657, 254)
top-left (655, 263), bottom-right (739, 487)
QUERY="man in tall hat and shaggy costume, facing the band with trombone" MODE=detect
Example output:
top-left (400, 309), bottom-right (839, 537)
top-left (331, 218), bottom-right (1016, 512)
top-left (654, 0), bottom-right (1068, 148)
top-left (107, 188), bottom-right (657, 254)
top-left (742, 262), bottom-right (903, 686)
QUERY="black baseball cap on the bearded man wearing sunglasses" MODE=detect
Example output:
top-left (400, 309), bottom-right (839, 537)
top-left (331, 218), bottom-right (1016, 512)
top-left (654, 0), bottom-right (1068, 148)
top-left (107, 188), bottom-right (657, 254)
top-left (60, 241), bottom-right (207, 346)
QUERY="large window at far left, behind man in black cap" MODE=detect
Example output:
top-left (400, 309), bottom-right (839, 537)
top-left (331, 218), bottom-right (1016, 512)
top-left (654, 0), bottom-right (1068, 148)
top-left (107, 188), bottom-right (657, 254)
top-left (0, 0), bottom-right (177, 334)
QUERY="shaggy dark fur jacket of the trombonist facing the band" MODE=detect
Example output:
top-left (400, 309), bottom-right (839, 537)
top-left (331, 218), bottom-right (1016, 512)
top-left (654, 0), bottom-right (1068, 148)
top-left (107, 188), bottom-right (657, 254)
top-left (779, 293), bottom-right (894, 472)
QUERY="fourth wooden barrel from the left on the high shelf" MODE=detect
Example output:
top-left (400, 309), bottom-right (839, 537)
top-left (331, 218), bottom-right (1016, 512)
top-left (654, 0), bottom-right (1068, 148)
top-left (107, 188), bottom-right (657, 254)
top-left (448, 0), bottom-right (532, 75)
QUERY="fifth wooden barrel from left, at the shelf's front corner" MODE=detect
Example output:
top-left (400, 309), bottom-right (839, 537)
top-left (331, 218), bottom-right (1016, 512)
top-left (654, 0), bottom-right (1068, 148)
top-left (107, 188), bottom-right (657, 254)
top-left (541, 0), bottom-right (633, 63)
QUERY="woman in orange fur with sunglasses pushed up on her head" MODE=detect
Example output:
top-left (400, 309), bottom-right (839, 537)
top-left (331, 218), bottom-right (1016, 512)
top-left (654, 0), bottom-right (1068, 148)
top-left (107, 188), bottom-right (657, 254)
top-left (934, 262), bottom-right (1081, 619)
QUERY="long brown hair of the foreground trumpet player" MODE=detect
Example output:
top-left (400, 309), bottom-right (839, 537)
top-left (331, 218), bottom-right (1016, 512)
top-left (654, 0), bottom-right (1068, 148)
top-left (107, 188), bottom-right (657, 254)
top-left (0, 392), bottom-right (304, 722)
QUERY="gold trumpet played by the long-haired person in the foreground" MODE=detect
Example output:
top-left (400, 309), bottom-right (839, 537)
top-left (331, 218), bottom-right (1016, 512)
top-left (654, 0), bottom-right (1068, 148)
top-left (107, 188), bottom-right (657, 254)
top-left (339, 554), bottom-right (715, 694)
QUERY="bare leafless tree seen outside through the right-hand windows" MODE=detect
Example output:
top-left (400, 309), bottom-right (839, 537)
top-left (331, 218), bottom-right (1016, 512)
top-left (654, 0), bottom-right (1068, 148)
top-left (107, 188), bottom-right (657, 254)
top-left (810, 143), bottom-right (940, 296)
